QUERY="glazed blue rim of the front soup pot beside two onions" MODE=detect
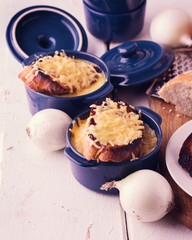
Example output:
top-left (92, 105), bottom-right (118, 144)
top-left (64, 107), bottom-right (162, 167)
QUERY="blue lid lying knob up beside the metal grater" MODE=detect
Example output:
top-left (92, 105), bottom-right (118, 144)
top-left (101, 41), bottom-right (174, 87)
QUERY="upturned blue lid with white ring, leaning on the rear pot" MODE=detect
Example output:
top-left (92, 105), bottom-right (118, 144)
top-left (6, 5), bottom-right (88, 62)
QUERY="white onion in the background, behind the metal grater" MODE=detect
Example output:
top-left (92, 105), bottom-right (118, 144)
top-left (150, 8), bottom-right (192, 48)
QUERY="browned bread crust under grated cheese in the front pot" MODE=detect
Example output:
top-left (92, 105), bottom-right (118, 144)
top-left (83, 100), bottom-right (143, 162)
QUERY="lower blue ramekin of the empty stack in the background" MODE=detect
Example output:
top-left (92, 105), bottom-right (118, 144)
top-left (83, 0), bottom-right (146, 42)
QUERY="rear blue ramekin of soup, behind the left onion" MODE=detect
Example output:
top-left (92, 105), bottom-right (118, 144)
top-left (23, 51), bottom-right (113, 118)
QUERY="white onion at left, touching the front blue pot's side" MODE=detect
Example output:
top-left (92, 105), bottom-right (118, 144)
top-left (26, 109), bottom-right (72, 151)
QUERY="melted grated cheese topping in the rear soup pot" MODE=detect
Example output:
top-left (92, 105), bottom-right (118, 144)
top-left (33, 52), bottom-right (107, 97)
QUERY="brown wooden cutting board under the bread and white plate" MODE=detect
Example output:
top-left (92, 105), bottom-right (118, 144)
top-left (148, 96), bottom-right (192, 229)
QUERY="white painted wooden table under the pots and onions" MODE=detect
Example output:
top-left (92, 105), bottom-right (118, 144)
top-left (0, 0), bottom-right (192, 240)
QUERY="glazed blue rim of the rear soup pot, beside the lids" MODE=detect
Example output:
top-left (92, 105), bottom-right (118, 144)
top-left (23, 50), bottom-right (113, 101)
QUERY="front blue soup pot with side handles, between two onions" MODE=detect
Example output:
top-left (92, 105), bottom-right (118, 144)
top-left (64, 107), bottom-right (162, 194)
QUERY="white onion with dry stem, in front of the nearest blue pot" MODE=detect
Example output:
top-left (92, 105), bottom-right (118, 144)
top-left (101, 170), bottom-right (174, 222)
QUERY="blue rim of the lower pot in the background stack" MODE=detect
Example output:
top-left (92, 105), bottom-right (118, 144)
top-left (83, 0), bottom-right (147, 15)
